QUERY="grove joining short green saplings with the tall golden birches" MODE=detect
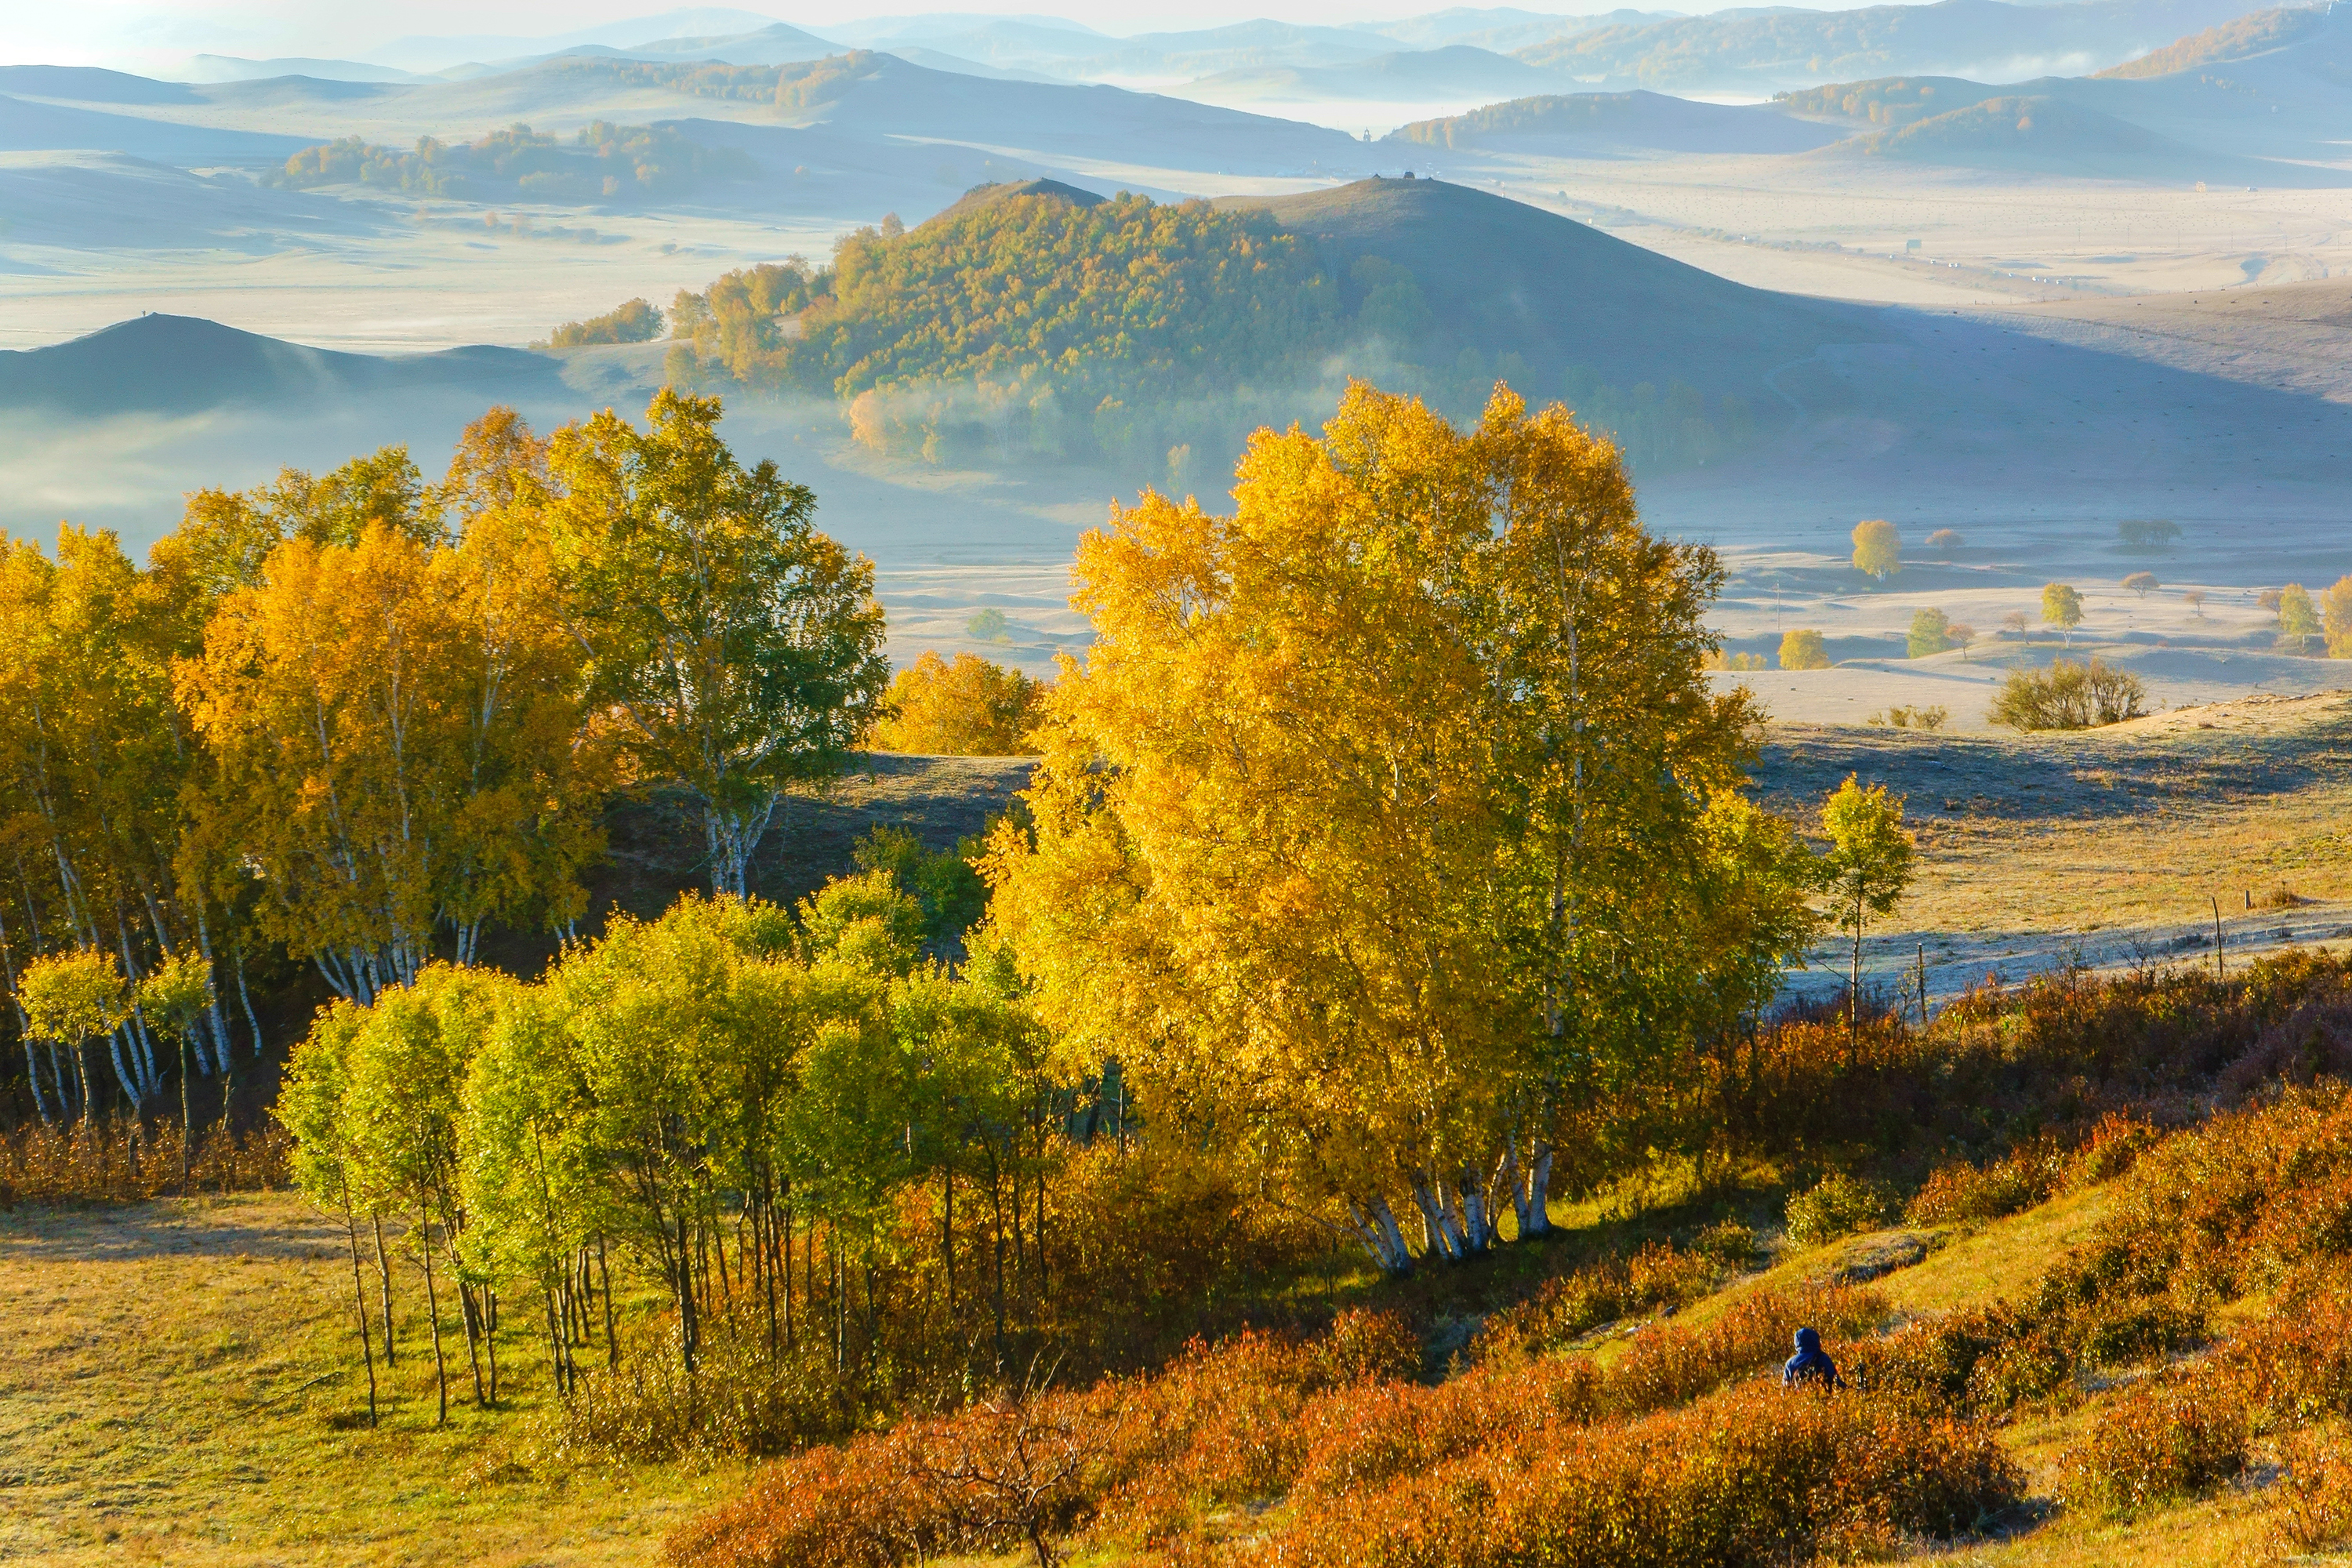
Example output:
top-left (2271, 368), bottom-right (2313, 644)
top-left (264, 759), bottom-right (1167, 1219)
top-left (243, 386), bottom-right (1853, 1450)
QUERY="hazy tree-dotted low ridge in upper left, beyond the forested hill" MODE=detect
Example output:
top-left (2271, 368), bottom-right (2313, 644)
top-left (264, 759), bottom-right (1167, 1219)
top-left (261, 120), bottom-right (760, 202)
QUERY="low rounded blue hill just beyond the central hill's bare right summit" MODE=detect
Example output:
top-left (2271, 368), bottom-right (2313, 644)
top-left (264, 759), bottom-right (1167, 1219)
top-left (1390, 92), bottom-right (1844, 153)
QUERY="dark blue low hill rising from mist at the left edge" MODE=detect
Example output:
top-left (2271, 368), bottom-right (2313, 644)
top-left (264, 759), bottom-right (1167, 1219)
top-left (0, 315), bottom-right (557, 419)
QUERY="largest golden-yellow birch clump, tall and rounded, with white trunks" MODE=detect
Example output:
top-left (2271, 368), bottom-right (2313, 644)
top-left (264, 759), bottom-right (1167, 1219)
top-left (990, 386), bottom-right (1748, 1269)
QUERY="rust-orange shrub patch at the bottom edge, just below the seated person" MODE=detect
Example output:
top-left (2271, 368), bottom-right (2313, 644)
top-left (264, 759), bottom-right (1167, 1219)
top-left (1240, 1382), bottom-right (2020, 1568)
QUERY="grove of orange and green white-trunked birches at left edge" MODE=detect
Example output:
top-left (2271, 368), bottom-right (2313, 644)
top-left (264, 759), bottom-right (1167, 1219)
top-left (0, 393), bottom-right (887, 1128)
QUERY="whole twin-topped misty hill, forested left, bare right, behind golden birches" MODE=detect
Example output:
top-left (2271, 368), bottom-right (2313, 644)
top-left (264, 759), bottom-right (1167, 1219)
top-left (668, 179), bottom-right (1877, 485)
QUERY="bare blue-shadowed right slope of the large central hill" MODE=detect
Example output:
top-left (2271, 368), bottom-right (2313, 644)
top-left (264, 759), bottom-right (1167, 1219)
top-left (1218, 179), bottom-right (1889, 395)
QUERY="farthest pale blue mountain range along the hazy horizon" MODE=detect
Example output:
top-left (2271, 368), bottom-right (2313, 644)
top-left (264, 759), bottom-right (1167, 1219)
top-left (101, 0), bottom-right (2286, 99)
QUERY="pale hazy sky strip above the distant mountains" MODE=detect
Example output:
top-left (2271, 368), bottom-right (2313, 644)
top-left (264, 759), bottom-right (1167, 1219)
top-left (13, 0), bottom-right (1910, 68)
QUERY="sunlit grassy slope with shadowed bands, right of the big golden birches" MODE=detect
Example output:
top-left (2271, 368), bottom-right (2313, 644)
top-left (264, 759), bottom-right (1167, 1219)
top-left (1757, 691), bottom-right (2352, 994)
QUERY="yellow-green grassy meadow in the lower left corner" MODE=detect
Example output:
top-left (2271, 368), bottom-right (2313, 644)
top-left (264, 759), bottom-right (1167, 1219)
top-left (0, 1194), bottom-right (734, 1568)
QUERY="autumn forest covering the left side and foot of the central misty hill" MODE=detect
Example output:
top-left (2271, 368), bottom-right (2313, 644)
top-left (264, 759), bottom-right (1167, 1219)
top-left (644, 188), bottom-right (1755, 474)
